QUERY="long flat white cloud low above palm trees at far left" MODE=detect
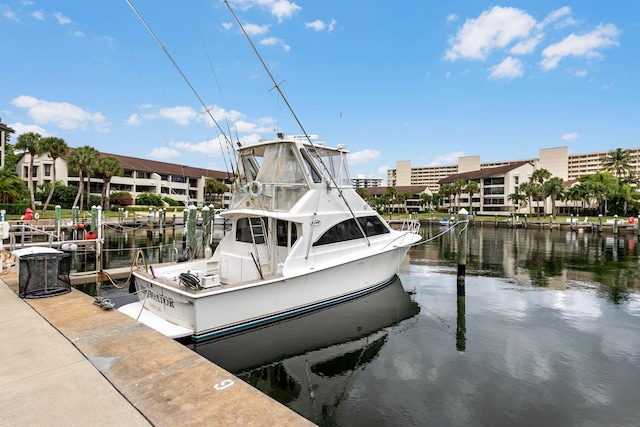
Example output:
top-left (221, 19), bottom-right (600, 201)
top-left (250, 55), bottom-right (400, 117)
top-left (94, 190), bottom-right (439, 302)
top-left (11, 95), bottom-right (108, 132)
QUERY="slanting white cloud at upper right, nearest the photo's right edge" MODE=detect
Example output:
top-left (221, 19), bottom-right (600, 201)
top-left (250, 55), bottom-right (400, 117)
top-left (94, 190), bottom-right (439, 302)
top-left (541, 24), bottom-right (620, 71)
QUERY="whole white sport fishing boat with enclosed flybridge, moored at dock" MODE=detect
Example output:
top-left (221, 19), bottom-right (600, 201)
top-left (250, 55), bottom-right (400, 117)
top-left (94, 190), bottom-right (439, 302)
top-left (120, 134), bottom-right (421, 341)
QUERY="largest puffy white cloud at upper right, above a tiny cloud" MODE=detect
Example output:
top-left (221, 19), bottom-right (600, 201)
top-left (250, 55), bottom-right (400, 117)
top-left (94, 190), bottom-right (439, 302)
top-left (445, 6), bottom-right (536, 61)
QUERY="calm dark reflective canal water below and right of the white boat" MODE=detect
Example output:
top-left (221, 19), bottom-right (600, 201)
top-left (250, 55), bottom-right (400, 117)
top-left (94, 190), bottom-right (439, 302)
top-left (180, 227), bottom-right (640, 427)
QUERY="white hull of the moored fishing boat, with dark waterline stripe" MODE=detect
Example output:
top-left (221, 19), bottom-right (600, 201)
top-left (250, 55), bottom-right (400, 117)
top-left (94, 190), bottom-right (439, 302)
top-left (121, 247), bottom-right (408, 341)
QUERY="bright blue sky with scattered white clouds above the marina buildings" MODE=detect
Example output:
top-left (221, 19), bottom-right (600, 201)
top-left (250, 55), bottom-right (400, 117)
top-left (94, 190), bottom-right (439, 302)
top-left (0, 0), bottom-right (640, 178)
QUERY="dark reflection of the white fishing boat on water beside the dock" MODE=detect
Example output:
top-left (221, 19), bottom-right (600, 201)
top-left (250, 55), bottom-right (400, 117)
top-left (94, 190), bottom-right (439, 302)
top-left (187, 276), bottom-right (420, 425)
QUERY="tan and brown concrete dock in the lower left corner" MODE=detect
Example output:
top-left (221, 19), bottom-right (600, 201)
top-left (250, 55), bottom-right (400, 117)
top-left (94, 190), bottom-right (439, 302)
top-left (0, 272), bottom-right (313, 427)
